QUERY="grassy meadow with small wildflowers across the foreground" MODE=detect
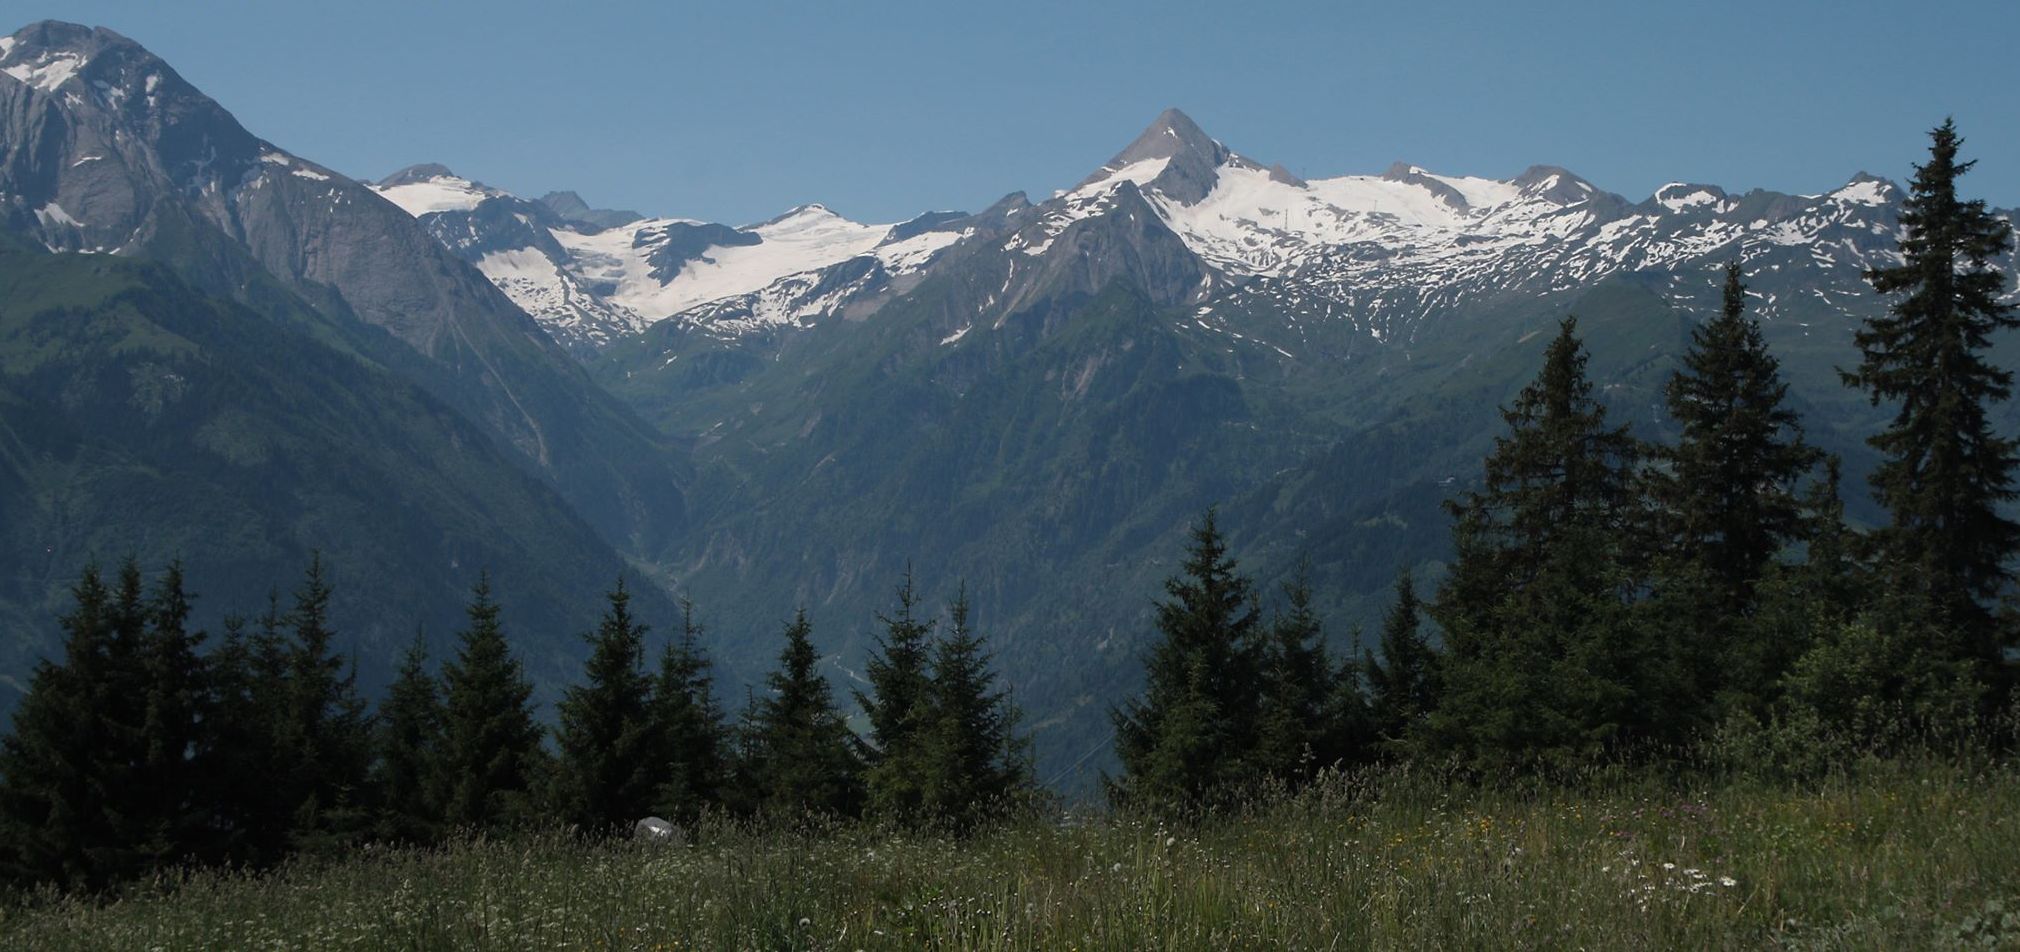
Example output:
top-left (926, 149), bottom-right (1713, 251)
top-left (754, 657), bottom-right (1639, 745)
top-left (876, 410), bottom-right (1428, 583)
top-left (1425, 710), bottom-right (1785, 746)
top-left (0, 760), bottom-right (2020, 950)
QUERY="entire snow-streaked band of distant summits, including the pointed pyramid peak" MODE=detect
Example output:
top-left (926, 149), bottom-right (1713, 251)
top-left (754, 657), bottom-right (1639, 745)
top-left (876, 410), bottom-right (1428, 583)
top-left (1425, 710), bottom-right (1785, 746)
top-left (393, 109), bottom-right (2003, 361)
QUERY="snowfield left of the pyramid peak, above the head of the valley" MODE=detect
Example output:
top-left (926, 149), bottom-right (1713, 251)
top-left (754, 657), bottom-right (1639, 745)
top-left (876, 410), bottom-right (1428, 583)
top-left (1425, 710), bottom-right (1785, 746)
top-left (374, 166), bottom-right (974, 352)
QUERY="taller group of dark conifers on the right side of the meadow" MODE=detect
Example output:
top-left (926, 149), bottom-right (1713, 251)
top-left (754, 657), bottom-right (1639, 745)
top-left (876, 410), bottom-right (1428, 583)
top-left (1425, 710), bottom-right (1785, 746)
top-left (1109, 121), bottom-right (2020, 806)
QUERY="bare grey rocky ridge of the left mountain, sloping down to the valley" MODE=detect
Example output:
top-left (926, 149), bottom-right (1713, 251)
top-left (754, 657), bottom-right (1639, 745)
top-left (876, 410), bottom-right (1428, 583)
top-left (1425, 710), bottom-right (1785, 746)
top-left (0, 22), bottom-right (689, 548)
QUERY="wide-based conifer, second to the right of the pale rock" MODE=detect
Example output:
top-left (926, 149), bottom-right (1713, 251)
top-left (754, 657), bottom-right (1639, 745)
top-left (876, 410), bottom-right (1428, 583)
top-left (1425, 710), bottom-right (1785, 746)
top-left (745, 610), bottom-right (863, 821)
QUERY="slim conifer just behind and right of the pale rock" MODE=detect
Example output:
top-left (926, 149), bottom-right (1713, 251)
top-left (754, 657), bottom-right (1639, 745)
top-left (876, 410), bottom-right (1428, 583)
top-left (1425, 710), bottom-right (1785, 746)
top-left (652, 598), bottom-right (729, 821)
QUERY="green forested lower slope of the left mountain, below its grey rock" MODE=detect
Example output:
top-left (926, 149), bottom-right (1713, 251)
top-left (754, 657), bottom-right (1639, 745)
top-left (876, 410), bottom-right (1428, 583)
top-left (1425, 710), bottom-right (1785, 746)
top-left (0, 243), bottom-right (671, 707)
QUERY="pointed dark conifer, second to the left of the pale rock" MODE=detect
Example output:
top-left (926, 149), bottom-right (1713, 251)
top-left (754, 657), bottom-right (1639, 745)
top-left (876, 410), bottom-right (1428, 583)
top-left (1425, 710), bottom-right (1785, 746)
top-left (442, 574), bottom-right (541, 829)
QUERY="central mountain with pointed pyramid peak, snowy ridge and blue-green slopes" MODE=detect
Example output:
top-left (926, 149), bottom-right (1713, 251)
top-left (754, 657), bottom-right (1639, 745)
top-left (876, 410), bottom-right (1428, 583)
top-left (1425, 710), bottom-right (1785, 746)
top-left (598, 113), bottom-right (2020, 788)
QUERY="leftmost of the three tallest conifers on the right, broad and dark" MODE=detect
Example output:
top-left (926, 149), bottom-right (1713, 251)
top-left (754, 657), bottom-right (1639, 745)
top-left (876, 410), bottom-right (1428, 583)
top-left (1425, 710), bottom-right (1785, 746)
top-left (1424, 317), bottom-right (1671, 766)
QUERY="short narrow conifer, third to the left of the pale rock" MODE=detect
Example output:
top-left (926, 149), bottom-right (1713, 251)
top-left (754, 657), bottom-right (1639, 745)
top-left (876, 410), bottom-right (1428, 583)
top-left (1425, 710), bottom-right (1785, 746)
top-left (372, 633), bottom-right (444, 843)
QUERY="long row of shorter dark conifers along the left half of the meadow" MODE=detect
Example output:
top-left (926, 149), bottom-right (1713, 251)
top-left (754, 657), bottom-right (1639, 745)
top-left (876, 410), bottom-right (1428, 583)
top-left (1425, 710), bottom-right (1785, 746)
top-left (0, 558), bottom-right (1036, 891)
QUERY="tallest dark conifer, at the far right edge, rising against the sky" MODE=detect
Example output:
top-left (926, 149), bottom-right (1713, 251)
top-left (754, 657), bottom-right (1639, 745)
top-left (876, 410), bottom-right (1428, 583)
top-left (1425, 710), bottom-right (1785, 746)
top-left (1844, 119), bottom-right (2020, 663)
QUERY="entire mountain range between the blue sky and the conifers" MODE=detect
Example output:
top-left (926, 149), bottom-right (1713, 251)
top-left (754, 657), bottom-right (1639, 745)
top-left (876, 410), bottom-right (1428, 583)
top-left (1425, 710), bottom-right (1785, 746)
top-left (0, 22), bottom-right (2020, 788)
